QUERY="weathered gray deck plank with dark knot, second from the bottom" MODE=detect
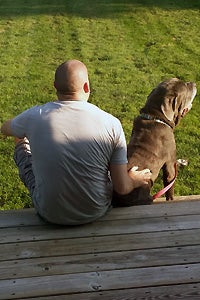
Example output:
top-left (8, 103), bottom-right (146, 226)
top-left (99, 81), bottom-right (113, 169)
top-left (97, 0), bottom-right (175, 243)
top-left (0, 264), bottom-right (200, 300)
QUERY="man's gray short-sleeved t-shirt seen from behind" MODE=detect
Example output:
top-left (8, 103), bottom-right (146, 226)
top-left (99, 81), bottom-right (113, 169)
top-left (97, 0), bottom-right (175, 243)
top-left (11, 101), bottom-right (127, 224)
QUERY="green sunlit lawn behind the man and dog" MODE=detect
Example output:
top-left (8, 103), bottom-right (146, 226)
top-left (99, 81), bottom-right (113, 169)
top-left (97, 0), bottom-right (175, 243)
top-left (0, 0), bottom-right (200, 209)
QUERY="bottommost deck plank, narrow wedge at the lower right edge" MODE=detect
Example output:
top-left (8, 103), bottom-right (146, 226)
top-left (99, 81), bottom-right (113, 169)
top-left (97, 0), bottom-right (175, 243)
top-left (20, 283), bottom-right (200, 300)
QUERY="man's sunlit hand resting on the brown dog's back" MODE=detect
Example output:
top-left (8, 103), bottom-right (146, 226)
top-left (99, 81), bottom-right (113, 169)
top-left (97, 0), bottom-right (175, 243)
top-left (128, 167), bottom-right (152, 188)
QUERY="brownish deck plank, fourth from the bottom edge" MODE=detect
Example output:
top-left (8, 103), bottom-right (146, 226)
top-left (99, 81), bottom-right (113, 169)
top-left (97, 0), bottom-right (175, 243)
top-left (0, 229), bottom-right (200, 261)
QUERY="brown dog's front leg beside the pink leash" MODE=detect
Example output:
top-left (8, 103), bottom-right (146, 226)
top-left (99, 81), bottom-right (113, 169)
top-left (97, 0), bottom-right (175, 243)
top-left (162, 161), bottom-right (176, 201)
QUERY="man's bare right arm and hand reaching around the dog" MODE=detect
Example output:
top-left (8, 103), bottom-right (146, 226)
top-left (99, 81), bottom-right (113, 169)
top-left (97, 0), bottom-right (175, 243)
top-left (110, 164), bottom-right (152, 195)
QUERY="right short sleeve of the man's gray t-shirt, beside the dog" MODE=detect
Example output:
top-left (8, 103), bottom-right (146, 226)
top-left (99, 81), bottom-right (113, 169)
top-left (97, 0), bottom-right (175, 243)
top-left (110, 120), bottom-right (128, 164)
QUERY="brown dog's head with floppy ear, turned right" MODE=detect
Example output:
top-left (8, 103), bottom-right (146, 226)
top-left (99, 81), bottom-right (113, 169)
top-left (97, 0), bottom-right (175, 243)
top-left (141, 78), bottom-right (197, 126)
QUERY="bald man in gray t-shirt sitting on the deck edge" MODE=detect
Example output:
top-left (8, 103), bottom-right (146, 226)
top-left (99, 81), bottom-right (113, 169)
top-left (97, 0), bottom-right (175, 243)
top-left (1, 60), bottom-right (151, 225)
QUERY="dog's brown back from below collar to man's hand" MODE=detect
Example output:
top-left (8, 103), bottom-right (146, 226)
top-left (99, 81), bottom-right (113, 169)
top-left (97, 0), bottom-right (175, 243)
top-left (127, 116), bottom-right (176, 185)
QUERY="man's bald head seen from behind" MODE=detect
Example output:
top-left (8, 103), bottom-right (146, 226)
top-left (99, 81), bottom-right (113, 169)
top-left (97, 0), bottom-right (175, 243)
top-left (54, 60), bottom-right (89, 100)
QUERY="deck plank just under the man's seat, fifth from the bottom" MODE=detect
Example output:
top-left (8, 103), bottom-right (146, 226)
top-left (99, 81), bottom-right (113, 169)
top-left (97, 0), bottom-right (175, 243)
top-left (0, 215), bottom-right (200, 244)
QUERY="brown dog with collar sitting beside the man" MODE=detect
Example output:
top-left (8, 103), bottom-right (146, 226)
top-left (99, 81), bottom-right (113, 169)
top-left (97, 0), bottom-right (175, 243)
top-left (113, 78), bottom-right (197, 206)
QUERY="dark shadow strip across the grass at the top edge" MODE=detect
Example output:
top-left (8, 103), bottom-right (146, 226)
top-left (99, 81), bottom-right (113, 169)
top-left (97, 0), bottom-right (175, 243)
top-left (0, 0), bottom-right (200, 18)
